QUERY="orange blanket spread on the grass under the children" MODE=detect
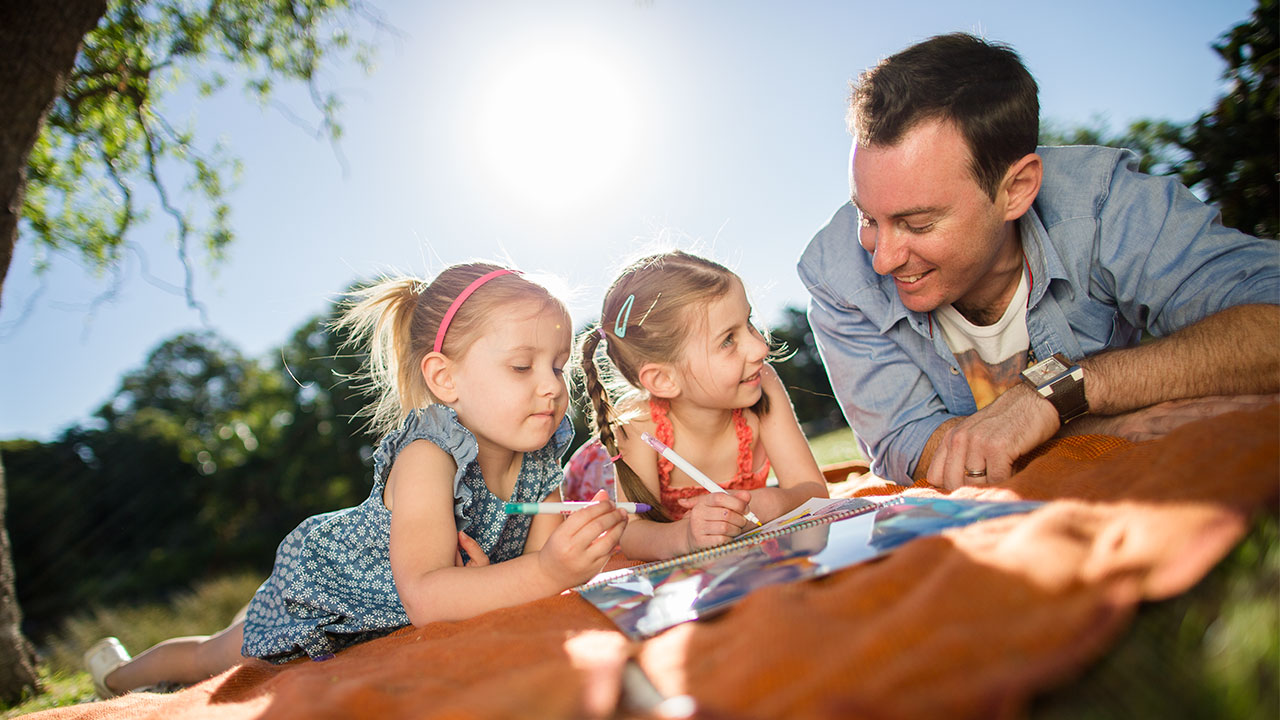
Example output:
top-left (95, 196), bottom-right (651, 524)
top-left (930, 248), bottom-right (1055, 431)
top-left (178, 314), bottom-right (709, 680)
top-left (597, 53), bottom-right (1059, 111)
top-left (38, 406), bottom-right (1280, 720)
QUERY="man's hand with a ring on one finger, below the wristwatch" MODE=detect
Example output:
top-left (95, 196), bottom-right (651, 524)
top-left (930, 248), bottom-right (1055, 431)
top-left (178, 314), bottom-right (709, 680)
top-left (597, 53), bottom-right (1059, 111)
top-left (928, 384), bottom-right (1060, 489)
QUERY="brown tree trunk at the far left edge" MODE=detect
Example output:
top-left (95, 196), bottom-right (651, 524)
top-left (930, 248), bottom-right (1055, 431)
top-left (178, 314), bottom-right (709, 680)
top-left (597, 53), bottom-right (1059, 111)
top-left (0, 0), bottom-right (106, 703)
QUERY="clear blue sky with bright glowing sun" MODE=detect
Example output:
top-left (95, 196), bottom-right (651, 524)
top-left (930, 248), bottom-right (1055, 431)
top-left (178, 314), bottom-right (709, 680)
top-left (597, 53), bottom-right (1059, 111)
top-left (0, 0), bottom-right (1252, 441)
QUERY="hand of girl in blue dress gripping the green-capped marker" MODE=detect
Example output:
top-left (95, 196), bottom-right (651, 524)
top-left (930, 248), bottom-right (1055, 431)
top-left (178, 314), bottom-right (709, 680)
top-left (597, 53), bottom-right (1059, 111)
top-left (538, 489), bottom-right (627, 588)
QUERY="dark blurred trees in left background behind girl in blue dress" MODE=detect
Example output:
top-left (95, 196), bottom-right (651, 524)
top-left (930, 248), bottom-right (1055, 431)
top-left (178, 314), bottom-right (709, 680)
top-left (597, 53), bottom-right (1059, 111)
top-left (4, 308), bottom-right (372, 638)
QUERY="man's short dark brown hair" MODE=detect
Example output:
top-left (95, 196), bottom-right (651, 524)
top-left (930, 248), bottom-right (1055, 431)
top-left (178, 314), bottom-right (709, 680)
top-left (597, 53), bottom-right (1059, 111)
top-left (849, 32), bottom-right (1039, 200)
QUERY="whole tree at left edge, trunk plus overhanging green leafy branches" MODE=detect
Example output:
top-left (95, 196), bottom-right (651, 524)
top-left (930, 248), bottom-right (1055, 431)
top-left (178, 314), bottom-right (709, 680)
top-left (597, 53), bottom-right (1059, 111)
top-left (0, 0), bottom-right (381, 702)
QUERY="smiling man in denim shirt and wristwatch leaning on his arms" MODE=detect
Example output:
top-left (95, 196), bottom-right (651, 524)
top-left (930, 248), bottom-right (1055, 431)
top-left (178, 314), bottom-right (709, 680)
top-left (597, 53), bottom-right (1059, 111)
top-left (799, 33), bottom-right (1280, 488)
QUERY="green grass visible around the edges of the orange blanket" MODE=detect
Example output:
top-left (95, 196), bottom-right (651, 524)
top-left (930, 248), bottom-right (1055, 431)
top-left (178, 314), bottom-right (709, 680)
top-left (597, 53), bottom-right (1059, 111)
top-left (0, 429), bottom-right (1280, 720)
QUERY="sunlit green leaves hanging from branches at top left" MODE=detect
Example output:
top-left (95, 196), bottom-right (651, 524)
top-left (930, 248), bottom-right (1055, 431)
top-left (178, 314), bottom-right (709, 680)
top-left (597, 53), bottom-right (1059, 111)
top-left (22, 0), bottom-right (380, 307)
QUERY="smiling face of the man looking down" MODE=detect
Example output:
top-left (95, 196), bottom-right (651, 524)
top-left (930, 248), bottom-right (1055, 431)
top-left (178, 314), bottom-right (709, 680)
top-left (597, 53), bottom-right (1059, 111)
top-left (850, 120), bottom-right (1020, 316)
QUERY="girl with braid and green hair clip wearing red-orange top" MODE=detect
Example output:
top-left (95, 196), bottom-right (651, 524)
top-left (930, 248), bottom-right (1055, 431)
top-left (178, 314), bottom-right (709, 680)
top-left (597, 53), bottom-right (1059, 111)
top-left (566, 251), bottom-right (827, 560)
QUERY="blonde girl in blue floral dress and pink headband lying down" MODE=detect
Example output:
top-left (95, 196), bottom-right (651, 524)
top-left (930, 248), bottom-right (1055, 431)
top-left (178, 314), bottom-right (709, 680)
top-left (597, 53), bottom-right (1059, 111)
top-left (86, 263), bottom-right (626, 697)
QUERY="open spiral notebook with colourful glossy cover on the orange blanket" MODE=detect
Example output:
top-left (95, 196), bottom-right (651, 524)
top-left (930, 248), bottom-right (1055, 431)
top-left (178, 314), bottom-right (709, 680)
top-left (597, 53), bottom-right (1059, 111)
top-left (573, 497), bottom-right (1041, 639)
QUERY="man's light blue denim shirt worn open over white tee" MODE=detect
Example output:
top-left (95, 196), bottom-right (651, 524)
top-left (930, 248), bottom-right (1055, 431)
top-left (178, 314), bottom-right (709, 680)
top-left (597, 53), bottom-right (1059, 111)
top-left (799, 147), bottom-right (1280, 484)
